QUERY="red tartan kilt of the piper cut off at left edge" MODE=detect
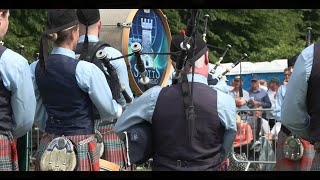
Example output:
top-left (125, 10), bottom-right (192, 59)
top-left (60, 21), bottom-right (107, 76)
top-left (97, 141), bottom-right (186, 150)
top-left (0, 132), bottom-right (19, 171)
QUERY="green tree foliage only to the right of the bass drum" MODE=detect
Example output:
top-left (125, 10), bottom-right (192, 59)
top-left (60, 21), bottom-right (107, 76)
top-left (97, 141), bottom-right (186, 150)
top-left (162, 9), bottom-right (312, 63)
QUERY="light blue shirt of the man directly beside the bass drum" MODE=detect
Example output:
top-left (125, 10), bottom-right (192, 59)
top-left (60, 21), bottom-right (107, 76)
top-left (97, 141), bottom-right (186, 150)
top-left (79, 35), bottom-right (133, 108)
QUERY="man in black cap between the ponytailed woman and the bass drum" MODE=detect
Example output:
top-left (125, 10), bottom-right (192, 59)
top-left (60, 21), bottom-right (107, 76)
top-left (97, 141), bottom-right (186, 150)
top-left (75, 9), bottom-right (133, 169)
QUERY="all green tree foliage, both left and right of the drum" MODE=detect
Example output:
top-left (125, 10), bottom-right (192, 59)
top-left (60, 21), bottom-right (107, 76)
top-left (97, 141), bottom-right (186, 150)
top-left (4, 9), bottom-right (320, 63)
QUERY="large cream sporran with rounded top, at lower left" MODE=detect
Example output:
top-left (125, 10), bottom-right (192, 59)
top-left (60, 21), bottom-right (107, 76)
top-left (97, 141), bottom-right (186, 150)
top-left (40, 136), bottom-right (77, 171)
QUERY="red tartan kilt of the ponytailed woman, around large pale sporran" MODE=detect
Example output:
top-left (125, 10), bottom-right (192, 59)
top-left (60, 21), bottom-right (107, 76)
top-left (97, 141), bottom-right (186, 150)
top-left (35, 133), bottom-right (99, 171)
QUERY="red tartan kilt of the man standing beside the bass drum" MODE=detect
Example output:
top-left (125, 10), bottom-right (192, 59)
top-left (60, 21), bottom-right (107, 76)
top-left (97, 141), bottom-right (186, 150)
top-left (95, 120), bottom-right (128, 170)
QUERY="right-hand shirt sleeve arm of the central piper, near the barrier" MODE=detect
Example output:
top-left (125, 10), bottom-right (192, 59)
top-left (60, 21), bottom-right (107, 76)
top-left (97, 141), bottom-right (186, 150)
top-left (217, 91), bottom-right (237, 160)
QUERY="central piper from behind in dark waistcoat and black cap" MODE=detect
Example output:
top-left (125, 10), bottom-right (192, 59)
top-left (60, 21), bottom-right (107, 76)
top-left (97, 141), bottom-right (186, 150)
top-left (115, 35), bottom-right (237, 171)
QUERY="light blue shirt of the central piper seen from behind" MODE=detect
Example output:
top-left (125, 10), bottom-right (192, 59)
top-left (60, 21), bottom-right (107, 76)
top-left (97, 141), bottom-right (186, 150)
top-left (115, 74), bottom-right (237, 159)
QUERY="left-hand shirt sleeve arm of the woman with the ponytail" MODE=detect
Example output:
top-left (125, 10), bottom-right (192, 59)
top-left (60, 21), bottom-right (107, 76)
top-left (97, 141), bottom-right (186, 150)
top-left (30, 61), bottom-right (48, 132)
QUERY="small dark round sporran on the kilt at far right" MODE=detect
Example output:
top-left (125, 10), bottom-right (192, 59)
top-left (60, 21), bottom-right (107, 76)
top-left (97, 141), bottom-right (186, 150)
top-left (283, 136), bottom-right (304, 161)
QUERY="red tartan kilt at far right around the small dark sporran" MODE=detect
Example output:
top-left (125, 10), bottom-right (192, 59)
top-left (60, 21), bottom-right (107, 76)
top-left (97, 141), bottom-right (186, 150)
top-left (275, 131), bottom-right (315, 171)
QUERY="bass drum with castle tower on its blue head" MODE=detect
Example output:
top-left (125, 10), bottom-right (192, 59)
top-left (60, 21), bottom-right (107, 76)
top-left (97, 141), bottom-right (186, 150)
top-left (99, 9), bottom-right (171, 95)
